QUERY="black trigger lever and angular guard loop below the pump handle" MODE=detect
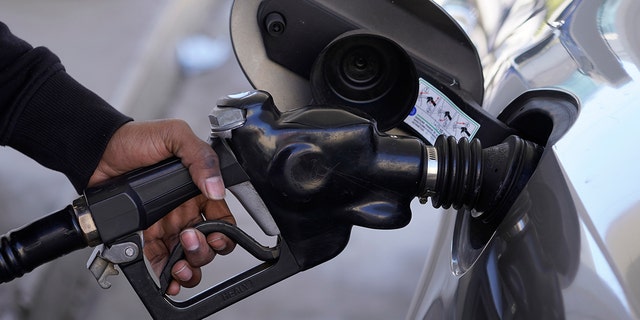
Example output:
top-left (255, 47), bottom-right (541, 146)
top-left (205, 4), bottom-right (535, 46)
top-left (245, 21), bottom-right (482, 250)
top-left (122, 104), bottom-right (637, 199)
top-left (120, 221), bottom-right (303, 319)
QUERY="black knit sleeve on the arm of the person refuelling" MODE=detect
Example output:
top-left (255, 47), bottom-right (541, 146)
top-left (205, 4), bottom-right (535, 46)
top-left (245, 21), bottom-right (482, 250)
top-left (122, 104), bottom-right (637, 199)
top-left (0, 22), bottom-right (131, 191)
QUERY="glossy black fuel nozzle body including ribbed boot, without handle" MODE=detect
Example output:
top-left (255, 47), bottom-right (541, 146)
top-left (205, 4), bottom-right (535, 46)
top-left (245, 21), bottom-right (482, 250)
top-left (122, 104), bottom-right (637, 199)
top-left (220, 91), bottom-right (542, 268)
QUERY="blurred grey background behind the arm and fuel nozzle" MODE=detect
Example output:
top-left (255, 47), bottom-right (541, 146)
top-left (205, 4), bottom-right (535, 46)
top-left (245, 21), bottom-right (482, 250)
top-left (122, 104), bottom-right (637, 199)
top-left (0, 0), bottom-right (439, 320)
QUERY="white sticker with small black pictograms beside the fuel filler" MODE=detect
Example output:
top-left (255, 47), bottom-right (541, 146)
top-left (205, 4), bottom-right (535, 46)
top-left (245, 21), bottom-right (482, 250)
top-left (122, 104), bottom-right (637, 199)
top-left (404, 78), bottom-right (480, 144)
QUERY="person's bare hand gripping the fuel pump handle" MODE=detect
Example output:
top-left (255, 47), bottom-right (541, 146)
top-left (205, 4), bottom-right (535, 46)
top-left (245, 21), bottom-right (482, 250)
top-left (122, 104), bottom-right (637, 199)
top-left (89, 120), bottom-right (235, 295)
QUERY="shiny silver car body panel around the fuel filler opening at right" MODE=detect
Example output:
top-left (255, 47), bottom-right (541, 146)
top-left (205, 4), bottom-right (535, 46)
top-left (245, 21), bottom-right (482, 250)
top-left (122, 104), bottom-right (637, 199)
top-left (407, 0), bottom-right (640, 319)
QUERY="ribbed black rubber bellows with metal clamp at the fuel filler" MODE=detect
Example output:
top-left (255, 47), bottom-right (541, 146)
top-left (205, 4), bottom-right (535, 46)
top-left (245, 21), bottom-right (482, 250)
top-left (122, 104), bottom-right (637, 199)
top-left (418, 136), bottom-right (542, 221)
